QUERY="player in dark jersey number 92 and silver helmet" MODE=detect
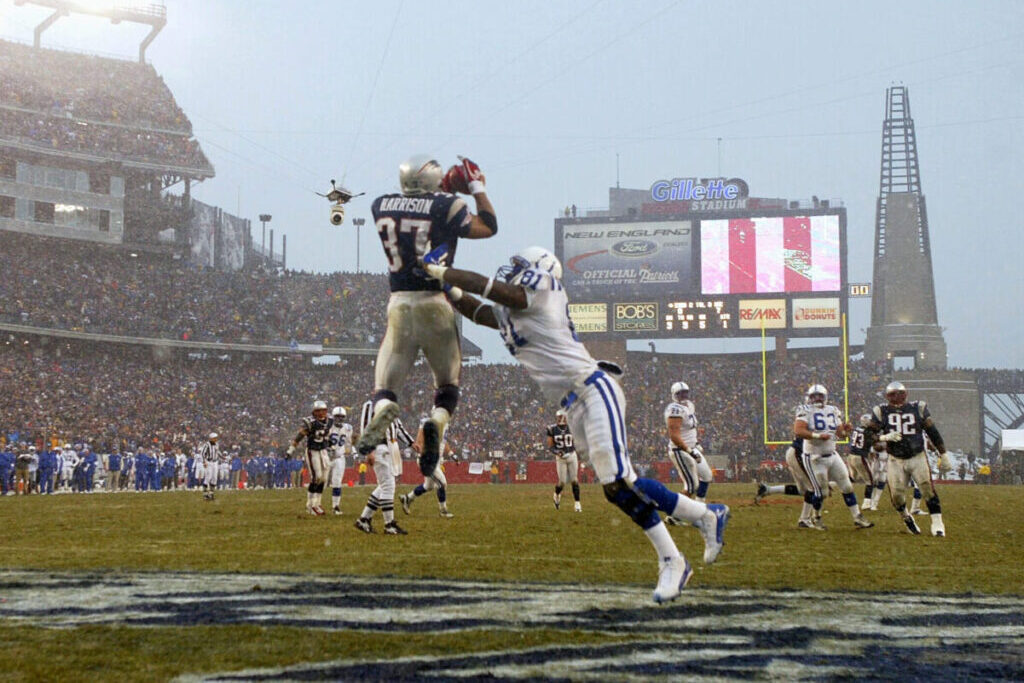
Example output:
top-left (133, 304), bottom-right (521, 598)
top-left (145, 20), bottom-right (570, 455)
top-left (869, 382), bottom-right (951, 537)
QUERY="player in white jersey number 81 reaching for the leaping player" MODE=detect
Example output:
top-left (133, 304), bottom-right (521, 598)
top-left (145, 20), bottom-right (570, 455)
top-left (423, 247), bottom-right (729, 603)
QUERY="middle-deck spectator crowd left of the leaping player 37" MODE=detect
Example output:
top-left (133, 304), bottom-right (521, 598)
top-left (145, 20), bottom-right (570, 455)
top-left (0, 231), bottom-right (388, 345)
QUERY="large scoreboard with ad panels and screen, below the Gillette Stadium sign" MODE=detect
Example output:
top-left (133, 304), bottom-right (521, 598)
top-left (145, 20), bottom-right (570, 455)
top-left (555, 207), bottom-right (848, 339)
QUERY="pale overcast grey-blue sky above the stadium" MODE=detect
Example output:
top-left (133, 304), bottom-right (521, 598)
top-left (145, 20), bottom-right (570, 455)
top-left (0, 0), bottom-right (1024, 368)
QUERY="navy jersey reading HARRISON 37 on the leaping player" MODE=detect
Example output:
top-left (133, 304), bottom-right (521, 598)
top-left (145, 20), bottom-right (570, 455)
top-left (373, 193), bottom-right (472, 292)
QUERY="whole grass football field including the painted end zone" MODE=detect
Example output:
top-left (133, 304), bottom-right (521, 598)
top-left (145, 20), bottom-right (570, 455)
top-left (0, 484), bottom-right (1024, 680)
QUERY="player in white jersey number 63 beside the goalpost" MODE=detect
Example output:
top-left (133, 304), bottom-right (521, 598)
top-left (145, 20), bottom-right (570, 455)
top-left (793, 384), bottom-right (874, 528)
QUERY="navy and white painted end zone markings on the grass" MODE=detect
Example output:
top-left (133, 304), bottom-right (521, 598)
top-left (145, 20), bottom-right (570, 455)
top-left (0, 571), bottom-right (1024, 680)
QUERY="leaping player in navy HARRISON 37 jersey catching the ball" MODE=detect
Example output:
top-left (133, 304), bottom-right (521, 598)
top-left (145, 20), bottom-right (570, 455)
top-left (357, 155), bottom-right (498, 485)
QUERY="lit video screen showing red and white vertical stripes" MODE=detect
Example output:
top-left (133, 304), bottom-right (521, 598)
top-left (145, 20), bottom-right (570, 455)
top-left (700, 215), bottom-right (840, 294)
